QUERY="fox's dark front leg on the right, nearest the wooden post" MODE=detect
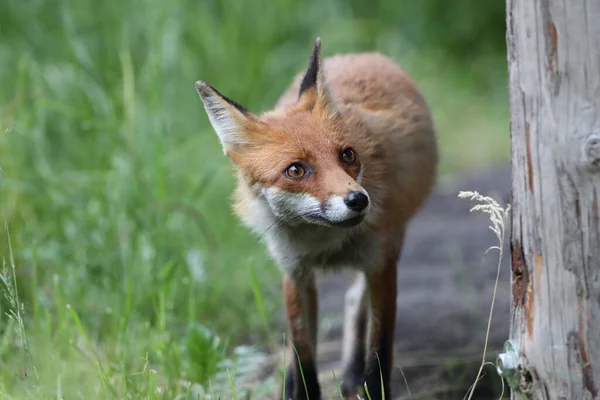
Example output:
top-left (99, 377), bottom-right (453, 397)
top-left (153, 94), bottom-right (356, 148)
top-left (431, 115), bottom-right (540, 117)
top-left (365, 241), bottom-right (400, 400)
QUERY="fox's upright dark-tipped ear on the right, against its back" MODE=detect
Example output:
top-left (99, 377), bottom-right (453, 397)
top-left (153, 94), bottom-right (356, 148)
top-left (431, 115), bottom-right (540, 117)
top-left (298, 38), bottom-right (338, 117)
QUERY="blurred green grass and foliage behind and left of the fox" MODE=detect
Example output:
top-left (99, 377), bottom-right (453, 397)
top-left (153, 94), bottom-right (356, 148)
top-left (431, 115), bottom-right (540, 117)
top-left (0, 0), bottom-right (509, 399)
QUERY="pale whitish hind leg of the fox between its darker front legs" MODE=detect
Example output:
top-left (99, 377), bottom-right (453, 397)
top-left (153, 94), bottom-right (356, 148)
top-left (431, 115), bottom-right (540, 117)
top-left (340, 272), bottom-right (368, 399)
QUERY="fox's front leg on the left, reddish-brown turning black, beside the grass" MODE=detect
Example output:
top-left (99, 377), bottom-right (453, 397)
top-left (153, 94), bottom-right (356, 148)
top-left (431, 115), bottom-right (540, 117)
top-left (283, 274), bottom-right (321, 400)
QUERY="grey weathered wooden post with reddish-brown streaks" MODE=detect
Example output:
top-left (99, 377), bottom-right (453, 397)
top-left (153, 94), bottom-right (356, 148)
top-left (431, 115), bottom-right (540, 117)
top-left (507, 0), bottom-right (600, 400)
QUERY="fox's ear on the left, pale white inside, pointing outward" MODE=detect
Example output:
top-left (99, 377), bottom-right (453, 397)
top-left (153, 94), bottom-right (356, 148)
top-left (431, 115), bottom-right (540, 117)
top-left (196, 81), bottom-right (256, 154)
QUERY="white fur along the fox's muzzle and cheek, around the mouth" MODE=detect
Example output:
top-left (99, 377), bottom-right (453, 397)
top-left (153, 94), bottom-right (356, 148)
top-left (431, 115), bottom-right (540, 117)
top-left (261, 188), bottom-right (370, 226)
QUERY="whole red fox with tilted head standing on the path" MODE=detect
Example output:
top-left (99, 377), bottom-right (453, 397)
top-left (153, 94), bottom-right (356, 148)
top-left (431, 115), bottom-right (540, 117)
top-left (196, 38), bottom-right (438, 400)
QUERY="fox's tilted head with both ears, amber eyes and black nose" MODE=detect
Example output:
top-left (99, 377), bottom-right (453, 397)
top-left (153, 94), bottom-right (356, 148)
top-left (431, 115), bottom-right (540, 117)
top-left (196, 38), bottom-right (371, 227)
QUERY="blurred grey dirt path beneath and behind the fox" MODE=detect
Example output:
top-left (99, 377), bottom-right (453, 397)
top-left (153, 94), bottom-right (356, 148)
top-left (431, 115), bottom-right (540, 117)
top-left (252, 166), bottom-right (510, 399)
